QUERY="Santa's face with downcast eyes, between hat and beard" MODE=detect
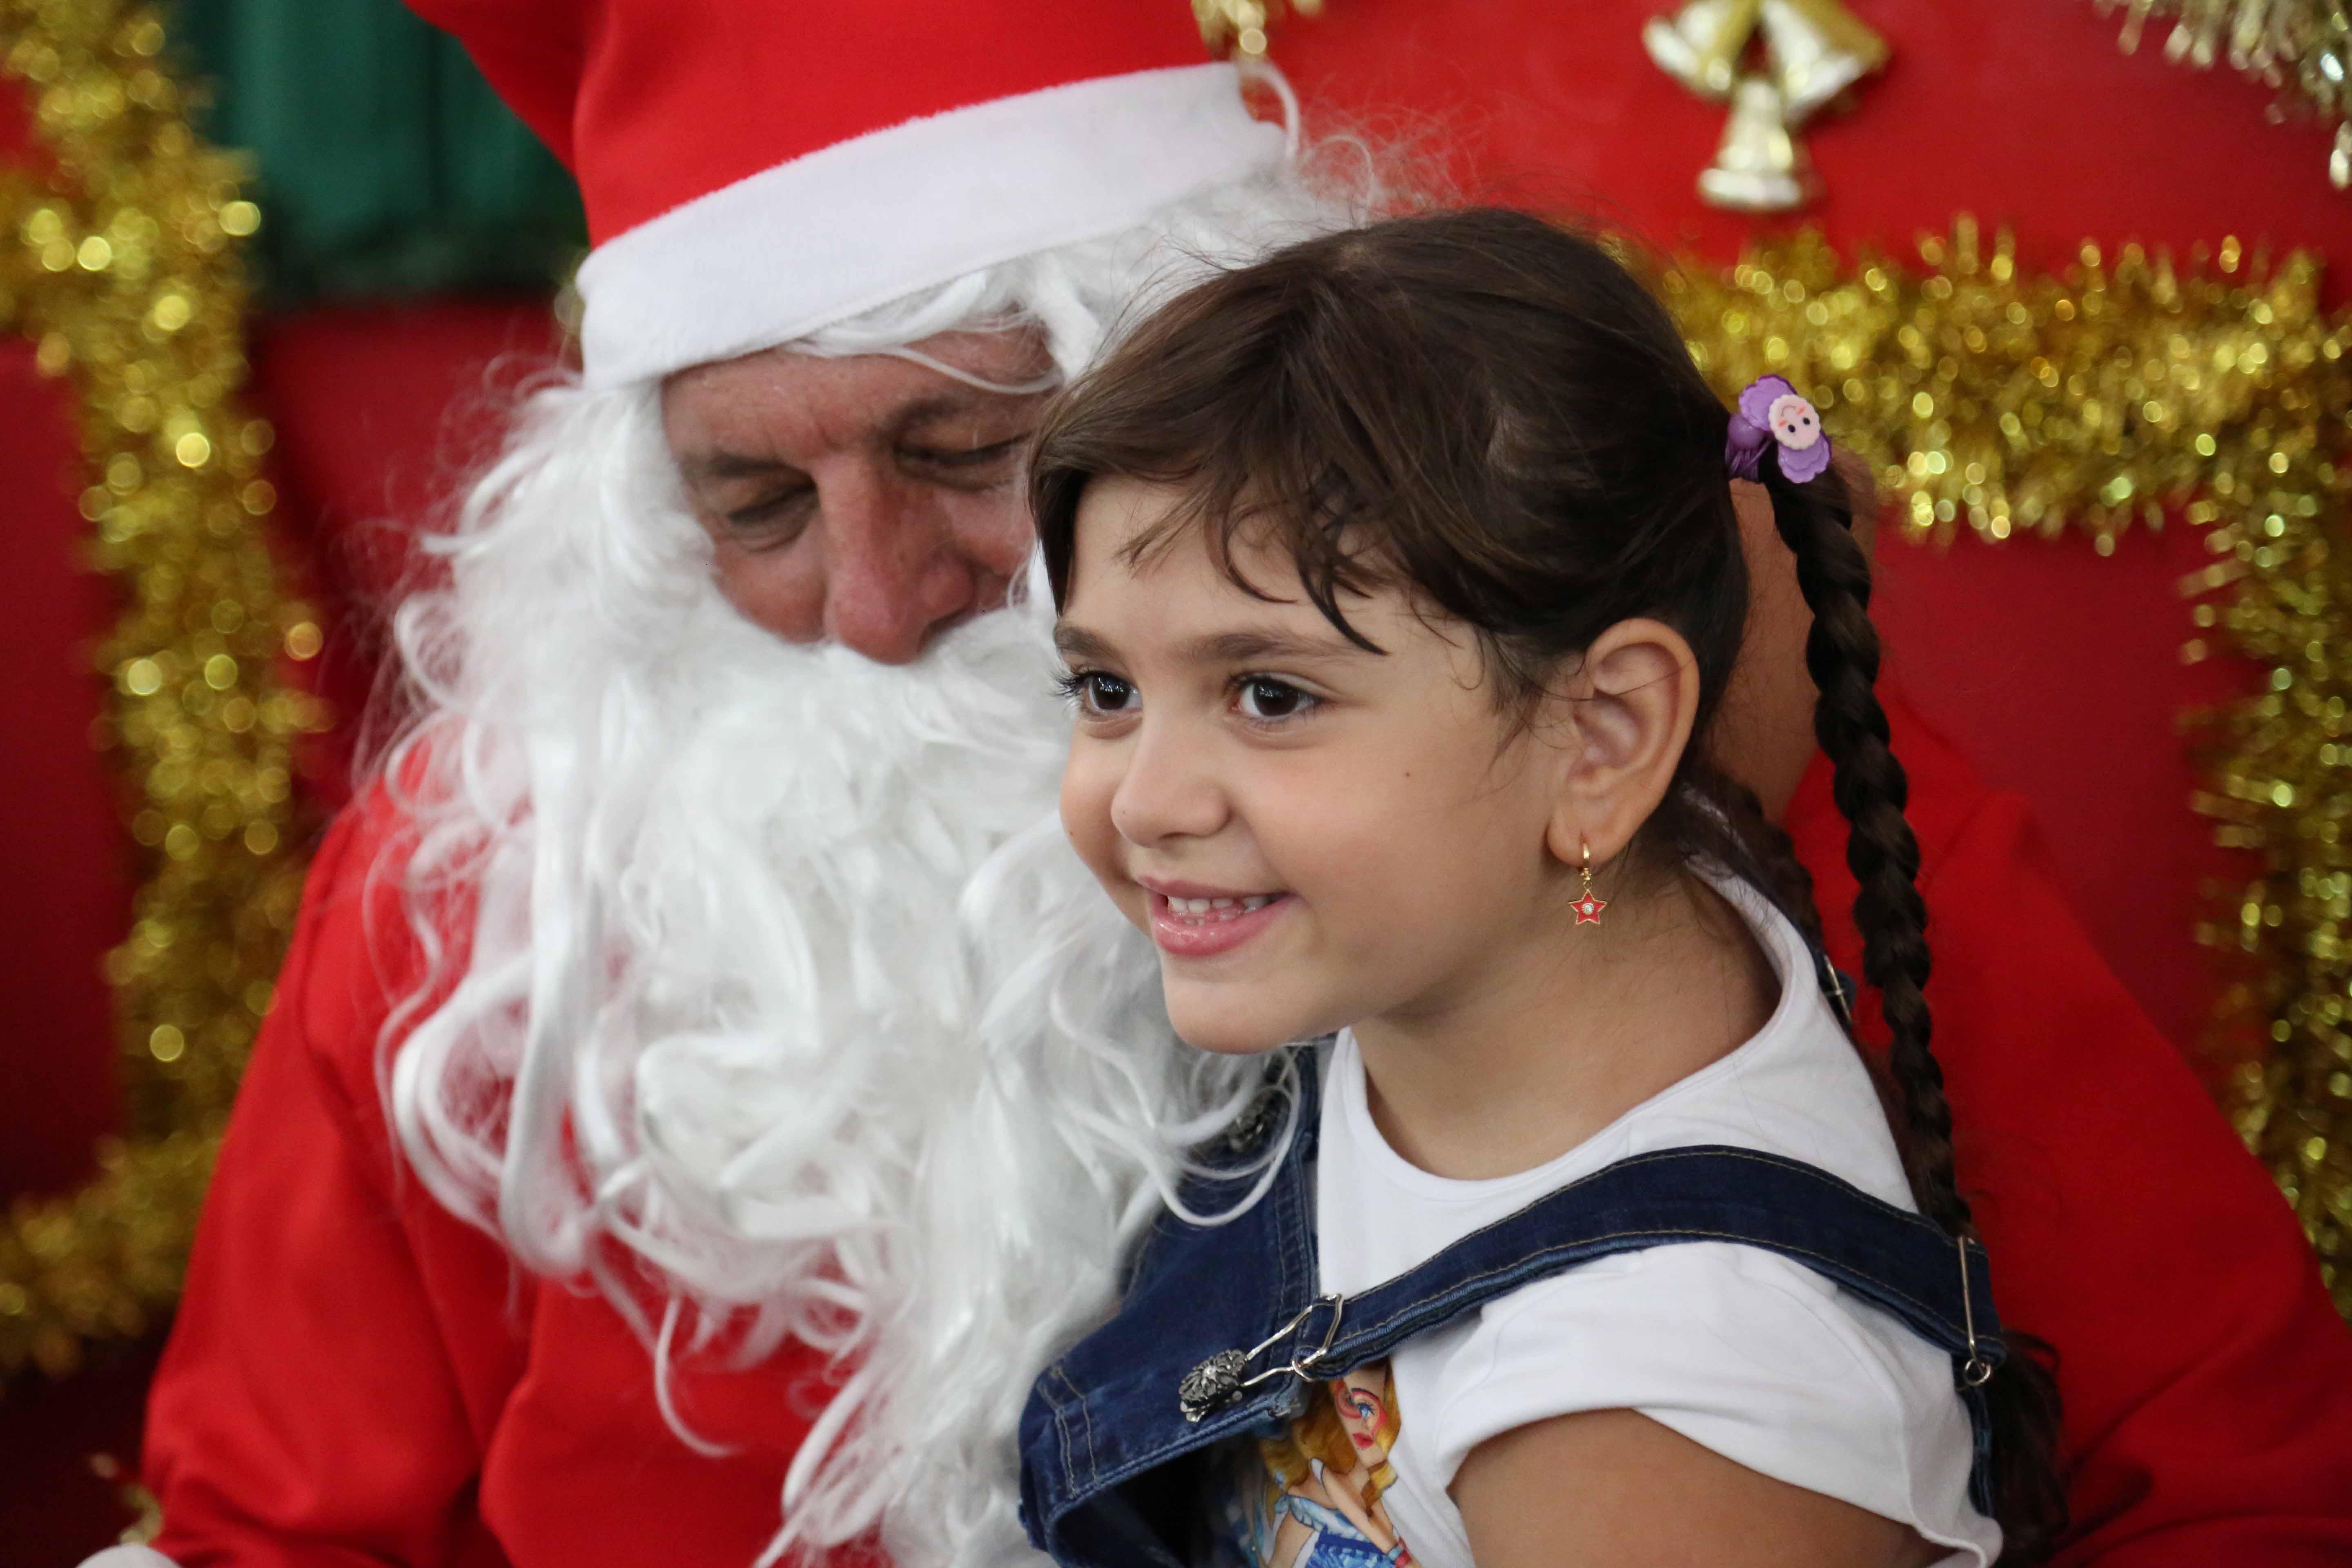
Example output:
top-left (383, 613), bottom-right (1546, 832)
top-left (661, 332), bottom-right (1051, 663)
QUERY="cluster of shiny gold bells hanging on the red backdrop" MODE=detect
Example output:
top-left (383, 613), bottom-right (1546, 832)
top-left (1642, 0), bottom-right (1889, 212)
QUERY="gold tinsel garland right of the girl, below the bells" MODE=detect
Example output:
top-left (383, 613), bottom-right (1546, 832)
top-left (1665, 218), bottom-right (2352, 1314)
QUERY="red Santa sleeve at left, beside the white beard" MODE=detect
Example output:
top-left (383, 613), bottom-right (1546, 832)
top-left (146, 799), bottom-right (529, 1568)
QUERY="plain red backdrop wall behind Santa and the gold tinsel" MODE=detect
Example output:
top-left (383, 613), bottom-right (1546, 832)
top-left (0, 0), bottom-right (2352, 1568)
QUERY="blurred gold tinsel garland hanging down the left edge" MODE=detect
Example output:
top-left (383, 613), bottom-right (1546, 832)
top-left (0, 0), bottom-right (322, 1375)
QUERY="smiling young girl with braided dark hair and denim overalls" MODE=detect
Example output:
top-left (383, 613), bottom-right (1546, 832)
top-left (1023, 212), bottom-right (2058, 1568)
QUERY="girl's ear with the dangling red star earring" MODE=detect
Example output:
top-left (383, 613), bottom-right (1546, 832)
top-left (1543, 618), bottom-right (1698, 865)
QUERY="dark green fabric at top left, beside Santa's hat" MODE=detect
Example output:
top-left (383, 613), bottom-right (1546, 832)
top-left (169, 0), bottom-right (588, 305)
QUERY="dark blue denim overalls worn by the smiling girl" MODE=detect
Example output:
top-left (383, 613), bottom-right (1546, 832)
top-left (1021, 945), bottom-right (2006, 1568)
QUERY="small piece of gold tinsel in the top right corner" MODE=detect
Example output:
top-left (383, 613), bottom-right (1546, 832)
top-left (2093, 0), bottom-right (2352, 190)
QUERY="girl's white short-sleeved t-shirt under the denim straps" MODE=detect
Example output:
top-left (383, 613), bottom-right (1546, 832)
top-left (1265, 884), bottom-right (2002, 1568)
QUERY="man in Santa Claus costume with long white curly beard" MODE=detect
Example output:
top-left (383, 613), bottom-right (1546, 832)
top-left (78, 0), bottom-right (2352, 1568)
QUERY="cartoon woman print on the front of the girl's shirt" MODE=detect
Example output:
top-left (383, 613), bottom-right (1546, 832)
top-left (1228, 1361), bottom-right (1414, 1568)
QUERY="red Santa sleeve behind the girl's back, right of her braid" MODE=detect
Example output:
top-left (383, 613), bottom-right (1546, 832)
top-left (1790, 701), bottom-right (2352, 1568)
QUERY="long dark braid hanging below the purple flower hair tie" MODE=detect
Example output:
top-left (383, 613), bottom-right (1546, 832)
top-left (1762, 454), bottom-right (2065, 1563)
